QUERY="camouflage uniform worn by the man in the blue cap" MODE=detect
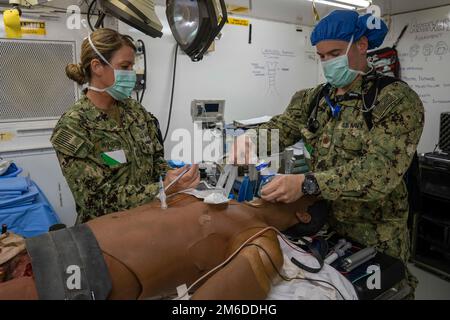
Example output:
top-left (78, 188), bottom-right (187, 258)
top-left (259, 73), bottom-right (423, 261)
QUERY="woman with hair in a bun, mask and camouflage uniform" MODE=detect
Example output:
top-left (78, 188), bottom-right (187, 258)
top-left (51, 29), bottom-right (199, 223)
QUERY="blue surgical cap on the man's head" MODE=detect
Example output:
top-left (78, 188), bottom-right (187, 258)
top-left (311, 10), bottom-right (388, 50)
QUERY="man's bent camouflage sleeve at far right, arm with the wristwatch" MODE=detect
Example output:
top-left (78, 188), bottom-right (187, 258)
top-left (315, 84), bottom-right (424, 201)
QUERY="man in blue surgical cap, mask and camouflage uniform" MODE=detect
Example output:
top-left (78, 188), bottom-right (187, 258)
top-left (237, 11), bottom-right (424, 296)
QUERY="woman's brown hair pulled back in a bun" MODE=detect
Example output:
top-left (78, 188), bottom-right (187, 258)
top-left (66, 28), bottom-right (136, 85)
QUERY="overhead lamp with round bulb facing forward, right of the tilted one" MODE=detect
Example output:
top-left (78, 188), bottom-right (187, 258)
top-left (166, 0), bottom-right (228, 61)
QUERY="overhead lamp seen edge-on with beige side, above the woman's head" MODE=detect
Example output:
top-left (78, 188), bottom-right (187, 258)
top-left (96, 0), bottom-right (163, 38)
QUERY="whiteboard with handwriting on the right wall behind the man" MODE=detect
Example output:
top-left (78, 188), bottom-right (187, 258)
top-left (386, 6), bottom-right (450, 153)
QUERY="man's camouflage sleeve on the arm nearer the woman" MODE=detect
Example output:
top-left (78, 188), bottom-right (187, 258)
top-left (258, 89), bottom-right (317, 153)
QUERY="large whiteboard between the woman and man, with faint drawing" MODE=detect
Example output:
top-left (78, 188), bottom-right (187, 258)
top-left (119, 7), bottom-right (318, 156)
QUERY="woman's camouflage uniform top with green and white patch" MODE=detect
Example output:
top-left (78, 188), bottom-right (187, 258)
top-left (51, 96), bottom-right (168, 223)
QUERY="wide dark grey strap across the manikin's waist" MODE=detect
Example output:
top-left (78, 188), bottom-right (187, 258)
top-left (26, 224), bottom-right (112, 300)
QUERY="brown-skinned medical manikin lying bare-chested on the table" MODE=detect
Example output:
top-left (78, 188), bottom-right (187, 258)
top-left (0, 195), bottom-right (319, 299)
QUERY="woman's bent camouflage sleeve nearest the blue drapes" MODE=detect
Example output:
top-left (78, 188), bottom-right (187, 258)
top-left (51, 119), bottom-right (159, 221)
